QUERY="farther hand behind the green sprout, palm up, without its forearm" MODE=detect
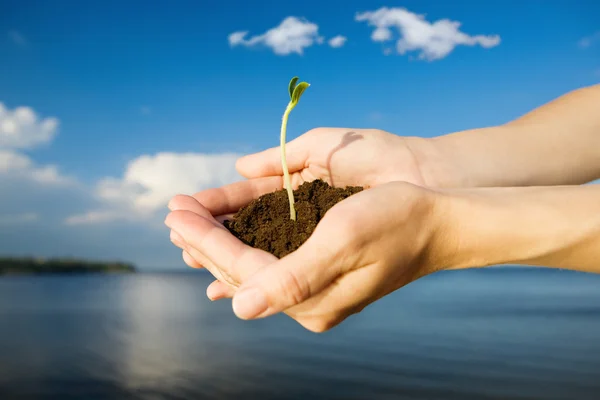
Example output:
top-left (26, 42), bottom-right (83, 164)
top-left (188, 128), bottom-right (426, 220)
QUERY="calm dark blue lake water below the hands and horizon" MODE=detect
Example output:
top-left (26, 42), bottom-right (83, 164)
top-left (0, 268), bottom-right (600, 400)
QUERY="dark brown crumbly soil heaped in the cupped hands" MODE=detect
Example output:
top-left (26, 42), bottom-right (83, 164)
top-left (224, 179), bottom-right (363, 258)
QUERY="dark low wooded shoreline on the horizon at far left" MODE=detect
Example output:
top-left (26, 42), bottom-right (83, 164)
top-left (0, 257), bottom-right (137, 276)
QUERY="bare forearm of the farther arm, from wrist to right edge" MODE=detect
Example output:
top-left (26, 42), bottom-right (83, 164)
top-left (411, 85), bottom-right (600, 187)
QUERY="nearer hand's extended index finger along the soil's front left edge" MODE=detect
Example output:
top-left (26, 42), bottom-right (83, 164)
top-left (165, 210), bottom-right (277, 284)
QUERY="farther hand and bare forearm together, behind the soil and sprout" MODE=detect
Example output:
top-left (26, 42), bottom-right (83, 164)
top-left (182, 85), bottom-right (600, 222)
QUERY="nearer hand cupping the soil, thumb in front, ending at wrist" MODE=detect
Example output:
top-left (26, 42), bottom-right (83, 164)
top-left (166, 182), bottom-right (447, 332)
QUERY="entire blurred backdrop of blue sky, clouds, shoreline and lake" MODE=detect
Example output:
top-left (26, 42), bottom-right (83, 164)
top-left (0, 0), bottom-right (600, 399)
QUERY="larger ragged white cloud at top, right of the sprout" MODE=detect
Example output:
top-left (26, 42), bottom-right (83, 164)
top-left (355, 7), bottom-right (500, 61)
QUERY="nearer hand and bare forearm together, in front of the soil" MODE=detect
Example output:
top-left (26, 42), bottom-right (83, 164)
top-left (166, 182), bottom-right (600, 332)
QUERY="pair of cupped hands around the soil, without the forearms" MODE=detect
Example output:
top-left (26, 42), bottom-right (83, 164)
top-left (165, 128), bottom-right (444, 332)
